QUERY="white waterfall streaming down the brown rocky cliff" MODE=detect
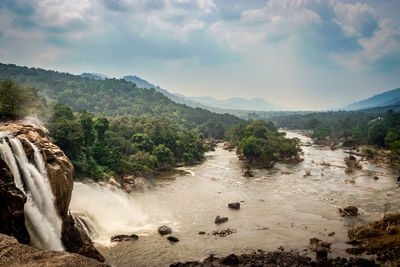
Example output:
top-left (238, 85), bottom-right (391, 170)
top-left (0, 132), bottom-right (64, 251)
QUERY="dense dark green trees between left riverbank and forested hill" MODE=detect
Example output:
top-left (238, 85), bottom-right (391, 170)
top-left (0, 80), bottom-right (216, 179)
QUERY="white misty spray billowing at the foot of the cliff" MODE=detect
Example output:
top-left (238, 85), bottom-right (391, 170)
top-left (70, 182), bottom-right (151, 245)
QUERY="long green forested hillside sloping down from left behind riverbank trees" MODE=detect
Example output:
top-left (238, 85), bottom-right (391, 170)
top-left (0, 63), bottom-right (242, 129)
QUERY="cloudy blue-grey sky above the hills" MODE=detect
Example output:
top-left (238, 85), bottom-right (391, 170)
top-left (0, 0), bottom-right (400, 110)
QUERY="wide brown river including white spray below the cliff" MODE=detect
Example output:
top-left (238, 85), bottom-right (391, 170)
top-left (71, 132), bottom-right (400, 266)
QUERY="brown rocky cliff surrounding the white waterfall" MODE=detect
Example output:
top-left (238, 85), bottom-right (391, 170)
top-left (0, 121), bottom-right (104, 261)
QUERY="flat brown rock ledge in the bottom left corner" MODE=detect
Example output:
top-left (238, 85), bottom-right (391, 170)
top-left (0, 234), bottom-right (109, 267)
